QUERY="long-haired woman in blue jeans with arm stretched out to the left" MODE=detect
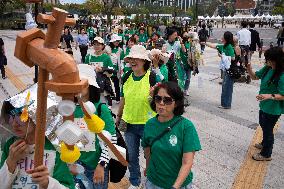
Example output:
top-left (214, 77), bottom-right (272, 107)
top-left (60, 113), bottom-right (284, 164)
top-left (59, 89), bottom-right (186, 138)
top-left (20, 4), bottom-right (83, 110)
top-left (205, 31), bottom-right (235, 109)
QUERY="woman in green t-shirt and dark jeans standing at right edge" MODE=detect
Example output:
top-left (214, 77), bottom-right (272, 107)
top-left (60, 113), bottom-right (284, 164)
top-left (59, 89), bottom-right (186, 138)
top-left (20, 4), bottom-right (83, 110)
top-left (247, 47), bottom-right (284, 161)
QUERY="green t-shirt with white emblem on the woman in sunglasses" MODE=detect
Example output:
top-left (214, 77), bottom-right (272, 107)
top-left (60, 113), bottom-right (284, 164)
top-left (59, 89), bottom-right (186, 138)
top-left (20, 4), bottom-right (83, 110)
top-left (142, 116), bottom-right (201, 189)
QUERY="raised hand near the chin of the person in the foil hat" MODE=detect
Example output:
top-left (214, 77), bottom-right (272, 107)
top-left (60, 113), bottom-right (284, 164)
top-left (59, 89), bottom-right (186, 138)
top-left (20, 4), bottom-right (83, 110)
top-left (6, 140), bottom-right (28, 173)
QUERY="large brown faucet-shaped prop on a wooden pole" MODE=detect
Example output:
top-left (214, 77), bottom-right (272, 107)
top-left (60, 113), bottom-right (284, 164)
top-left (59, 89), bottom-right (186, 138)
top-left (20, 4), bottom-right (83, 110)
top-left (15, 8), bottom-right (126, 167)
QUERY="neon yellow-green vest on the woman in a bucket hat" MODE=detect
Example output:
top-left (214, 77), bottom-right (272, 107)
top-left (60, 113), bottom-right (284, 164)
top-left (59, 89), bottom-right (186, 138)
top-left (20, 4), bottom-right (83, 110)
top-left (122, 71), bottom-right (155, 124)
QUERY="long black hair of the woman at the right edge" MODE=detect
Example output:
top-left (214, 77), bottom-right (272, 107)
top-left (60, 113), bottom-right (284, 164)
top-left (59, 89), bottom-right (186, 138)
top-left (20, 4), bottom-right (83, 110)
top-left (264, 47), bottom-right (284, 83)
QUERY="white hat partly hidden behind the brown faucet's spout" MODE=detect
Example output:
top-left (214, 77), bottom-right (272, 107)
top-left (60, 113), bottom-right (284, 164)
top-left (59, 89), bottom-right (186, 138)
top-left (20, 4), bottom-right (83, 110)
top-left (78, 64), bottom-right (100, 88)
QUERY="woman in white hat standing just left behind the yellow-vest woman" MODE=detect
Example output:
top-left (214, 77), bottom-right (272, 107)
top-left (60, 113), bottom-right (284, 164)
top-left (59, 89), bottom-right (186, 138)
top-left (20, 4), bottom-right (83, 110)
top-left (109, 34), bottom-right (122, 104)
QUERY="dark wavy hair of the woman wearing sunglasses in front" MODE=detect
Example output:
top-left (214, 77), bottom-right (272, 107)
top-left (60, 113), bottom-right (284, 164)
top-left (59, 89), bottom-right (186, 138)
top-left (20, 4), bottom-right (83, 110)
top-left (151, 82), bottom-right (184, 115)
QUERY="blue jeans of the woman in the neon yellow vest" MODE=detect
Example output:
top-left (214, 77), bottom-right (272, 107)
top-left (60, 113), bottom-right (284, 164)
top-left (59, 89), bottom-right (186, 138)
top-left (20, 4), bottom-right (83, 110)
top-left (125, 124), bottom-right (144, 186)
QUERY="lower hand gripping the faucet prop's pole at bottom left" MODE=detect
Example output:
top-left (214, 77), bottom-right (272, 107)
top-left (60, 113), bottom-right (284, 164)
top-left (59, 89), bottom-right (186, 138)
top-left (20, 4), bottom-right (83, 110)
top-left (27, 165), bottom-right (49, 189)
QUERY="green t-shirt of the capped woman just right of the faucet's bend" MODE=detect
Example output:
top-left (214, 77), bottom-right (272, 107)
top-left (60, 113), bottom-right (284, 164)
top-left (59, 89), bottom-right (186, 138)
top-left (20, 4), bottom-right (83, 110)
top-left (85, 53), bottom-right (113, 68)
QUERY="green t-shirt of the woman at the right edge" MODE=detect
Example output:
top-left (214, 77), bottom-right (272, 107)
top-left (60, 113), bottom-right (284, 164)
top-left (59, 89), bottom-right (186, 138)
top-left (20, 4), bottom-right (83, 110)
top-left (255, 66), bottom-right (284, 115)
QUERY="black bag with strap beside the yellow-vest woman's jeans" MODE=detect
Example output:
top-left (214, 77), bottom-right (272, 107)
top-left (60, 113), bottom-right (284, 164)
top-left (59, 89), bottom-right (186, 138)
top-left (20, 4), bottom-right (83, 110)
top-left (97, 103), bottom-right (129, 183)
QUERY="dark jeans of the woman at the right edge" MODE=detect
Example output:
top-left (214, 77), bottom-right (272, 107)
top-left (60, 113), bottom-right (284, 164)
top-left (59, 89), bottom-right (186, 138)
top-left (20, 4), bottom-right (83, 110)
top-left (259, 110), bottom-right (280, 157)
